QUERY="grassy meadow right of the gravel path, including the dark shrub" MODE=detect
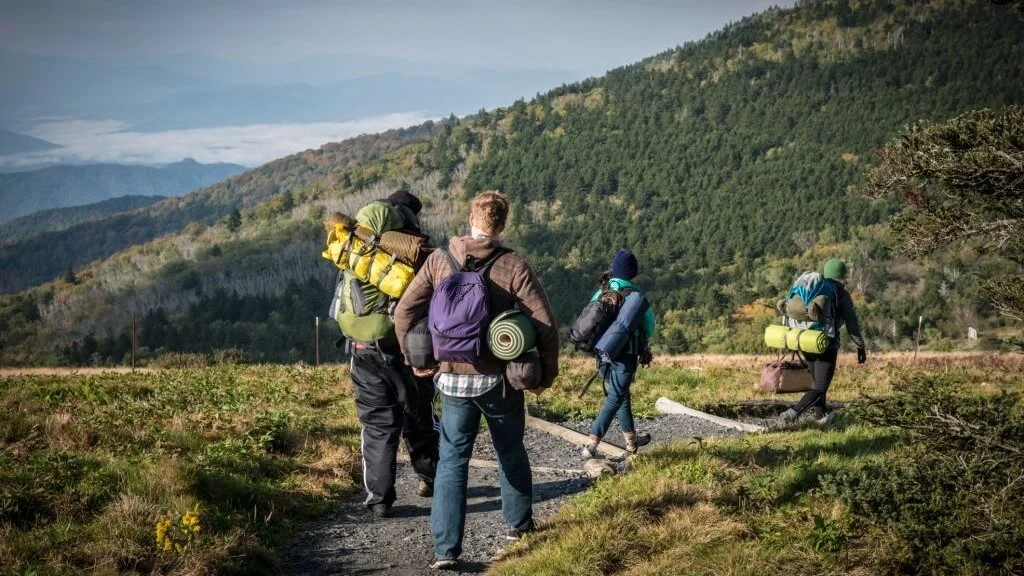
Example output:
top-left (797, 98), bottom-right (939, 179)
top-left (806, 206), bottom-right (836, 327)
top-left (490, 355), bottom-right (1024, 576)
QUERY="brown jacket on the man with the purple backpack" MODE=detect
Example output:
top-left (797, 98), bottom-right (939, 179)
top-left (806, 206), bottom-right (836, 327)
top-left (394, 236), bottom-right (558, 387)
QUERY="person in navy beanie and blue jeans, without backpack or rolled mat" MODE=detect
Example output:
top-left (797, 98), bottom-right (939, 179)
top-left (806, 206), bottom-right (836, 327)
top-left (583, 250), bottom-right (655, 458)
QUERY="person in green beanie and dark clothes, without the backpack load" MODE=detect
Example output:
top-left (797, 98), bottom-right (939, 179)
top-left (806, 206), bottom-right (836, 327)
top-left (779, 258), bottom-right (867, 424)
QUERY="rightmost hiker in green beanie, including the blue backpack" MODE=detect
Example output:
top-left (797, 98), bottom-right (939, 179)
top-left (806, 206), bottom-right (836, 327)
top-left (778, 258), bottom-right (867, 424)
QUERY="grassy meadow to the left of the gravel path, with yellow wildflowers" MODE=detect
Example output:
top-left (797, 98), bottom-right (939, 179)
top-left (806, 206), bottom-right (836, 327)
top-left (0, 365), bottom-right (358, 575)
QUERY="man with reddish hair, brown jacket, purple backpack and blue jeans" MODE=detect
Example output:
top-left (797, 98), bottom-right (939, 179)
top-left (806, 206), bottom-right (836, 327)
top-left (395, 191), bottom-right (558, 569)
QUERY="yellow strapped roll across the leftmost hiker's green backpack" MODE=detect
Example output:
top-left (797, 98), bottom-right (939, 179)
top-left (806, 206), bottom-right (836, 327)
top-left (322, 223), bottom-right (416, 298)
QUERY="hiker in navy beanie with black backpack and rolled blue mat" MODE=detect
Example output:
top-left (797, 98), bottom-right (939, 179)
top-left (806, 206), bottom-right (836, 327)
top-left (569, 250), bottom-right (655, 459)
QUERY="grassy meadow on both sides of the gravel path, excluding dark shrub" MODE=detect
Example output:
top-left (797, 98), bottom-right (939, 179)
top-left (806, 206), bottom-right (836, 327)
top-left (0, 355), bottom-right (1024, 575)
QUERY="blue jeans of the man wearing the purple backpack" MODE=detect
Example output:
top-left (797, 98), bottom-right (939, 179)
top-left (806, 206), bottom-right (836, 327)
top-left (430, 383), bottom-right (534, 558)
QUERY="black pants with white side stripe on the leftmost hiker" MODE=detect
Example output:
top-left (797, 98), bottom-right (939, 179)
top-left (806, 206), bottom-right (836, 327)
top-left (351, 345), bottom-right (438, 506)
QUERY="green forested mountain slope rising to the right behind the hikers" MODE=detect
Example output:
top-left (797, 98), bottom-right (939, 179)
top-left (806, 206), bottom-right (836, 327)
top-left (0, 1), bottom-right (1024, 362)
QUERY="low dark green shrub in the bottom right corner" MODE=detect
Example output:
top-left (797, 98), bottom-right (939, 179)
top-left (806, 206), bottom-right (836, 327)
top-left (822, 374), bottom-right (1024, 574)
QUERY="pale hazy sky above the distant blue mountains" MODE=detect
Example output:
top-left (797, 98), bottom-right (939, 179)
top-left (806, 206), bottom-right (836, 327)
top-left (0, 0), bottom-right (792, 74)
